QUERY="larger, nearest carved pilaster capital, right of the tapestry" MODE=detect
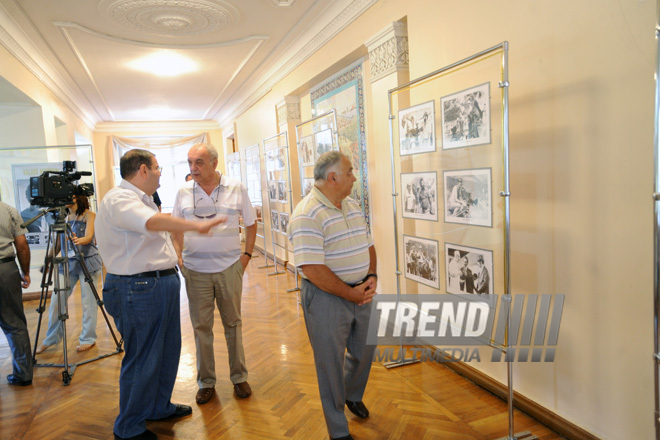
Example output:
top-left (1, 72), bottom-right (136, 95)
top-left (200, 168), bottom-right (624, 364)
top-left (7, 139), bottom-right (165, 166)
top-left (364, 21), bottom-right (410, 82)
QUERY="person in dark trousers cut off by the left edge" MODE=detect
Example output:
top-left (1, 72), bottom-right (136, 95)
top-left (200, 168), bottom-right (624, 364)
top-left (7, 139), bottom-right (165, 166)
top-left (0, 202), bottom-right (32, 386)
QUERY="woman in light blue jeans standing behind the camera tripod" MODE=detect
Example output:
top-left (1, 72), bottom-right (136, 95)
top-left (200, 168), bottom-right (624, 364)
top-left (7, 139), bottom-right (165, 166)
top-left (37, 195), bottom-right (102, 353)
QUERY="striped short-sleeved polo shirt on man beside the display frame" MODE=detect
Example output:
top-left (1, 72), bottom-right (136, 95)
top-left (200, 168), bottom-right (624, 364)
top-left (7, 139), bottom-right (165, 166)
top-left (289, 187), bottom-right (373, 283)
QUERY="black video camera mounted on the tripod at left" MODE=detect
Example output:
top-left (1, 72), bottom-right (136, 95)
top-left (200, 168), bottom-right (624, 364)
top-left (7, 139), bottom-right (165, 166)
top-left (30, 160), bottom-right (94, 208)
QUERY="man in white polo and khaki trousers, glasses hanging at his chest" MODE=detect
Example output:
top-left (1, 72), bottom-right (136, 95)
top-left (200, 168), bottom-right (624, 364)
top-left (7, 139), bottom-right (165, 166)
top-left (172, 144), bottom-right (257, 405)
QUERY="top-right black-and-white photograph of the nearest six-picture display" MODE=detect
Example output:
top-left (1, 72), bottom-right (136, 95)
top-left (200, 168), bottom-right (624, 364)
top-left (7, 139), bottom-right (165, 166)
top-left (440, 83), bottom-right (490, 150)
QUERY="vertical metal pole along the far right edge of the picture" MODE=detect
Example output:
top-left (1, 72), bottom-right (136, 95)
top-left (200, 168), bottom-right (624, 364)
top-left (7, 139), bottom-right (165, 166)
top-left (653, 2), bottom-right (660, 440)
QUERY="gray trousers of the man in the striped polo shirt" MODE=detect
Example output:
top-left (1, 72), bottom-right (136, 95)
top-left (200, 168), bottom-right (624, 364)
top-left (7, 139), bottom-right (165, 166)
top-left (301, 279), bottom-right (376, 438)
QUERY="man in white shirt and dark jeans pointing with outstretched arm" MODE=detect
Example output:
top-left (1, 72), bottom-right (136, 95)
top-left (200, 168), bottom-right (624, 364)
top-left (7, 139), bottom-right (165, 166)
top-left (96, 149), bottom-right (225, 440)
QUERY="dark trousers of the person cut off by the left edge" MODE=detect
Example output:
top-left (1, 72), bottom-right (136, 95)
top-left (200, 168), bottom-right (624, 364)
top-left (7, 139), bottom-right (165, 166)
top-left (0, 261), bottom-right (32, 380)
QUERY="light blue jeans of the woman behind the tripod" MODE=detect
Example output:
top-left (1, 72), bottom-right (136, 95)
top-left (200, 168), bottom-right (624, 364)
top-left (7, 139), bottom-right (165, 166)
top-left (43, 270), bottom-right (101, 345)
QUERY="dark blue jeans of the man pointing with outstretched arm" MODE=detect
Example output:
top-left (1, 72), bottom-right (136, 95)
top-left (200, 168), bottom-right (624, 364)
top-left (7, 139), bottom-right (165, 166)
top-left (103, 274), bottom-right (181, 437)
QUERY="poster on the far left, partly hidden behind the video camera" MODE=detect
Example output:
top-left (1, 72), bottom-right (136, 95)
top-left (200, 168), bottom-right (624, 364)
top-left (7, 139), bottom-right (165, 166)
top-left (11, 162), bottom-right (62, 248)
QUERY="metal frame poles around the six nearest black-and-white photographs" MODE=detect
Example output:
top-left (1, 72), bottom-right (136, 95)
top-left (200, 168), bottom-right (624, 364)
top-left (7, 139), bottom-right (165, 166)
top-left (386, 41), bottom-right (524, 440)
